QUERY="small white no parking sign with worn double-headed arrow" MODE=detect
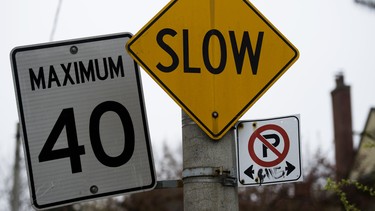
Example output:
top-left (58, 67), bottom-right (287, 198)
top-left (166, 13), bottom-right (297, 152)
top-left (236, 115), bottom-right (303, 187)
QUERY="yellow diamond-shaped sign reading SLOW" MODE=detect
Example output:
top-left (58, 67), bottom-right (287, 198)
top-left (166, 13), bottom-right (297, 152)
top-left (127, 0), bottom-right (299, 139)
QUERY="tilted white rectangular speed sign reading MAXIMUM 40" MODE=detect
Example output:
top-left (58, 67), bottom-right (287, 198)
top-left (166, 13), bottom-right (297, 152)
top-left (11, 33), bottom-right (156, 209)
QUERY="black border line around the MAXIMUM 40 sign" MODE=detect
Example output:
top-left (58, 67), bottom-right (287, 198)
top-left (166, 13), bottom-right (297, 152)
top-left (10, 33), bottom-right (156, 209)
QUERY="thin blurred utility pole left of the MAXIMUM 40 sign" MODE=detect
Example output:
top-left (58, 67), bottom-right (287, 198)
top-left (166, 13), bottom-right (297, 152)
top-left (11, 123), bottom-right (21, 211)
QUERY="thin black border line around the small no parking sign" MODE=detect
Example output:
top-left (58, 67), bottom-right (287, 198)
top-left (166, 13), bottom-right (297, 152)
top-left (235, 115), bottom-right (303, 187)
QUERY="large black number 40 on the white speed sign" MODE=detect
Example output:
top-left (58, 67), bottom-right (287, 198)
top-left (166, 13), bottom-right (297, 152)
top-left (38, 101), bottom-right (135, 173)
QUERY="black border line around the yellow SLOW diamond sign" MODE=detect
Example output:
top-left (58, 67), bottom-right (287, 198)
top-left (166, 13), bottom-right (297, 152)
top-left (126, 0), bottom-right (299, 138)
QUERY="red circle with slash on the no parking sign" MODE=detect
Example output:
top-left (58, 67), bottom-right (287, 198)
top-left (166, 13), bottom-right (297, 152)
top-left (248, 124), bottom-right (290, 167)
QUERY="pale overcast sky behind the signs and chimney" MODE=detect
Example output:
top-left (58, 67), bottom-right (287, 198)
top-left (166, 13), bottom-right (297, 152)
top-left (0, 0), bottom-right (375, 204)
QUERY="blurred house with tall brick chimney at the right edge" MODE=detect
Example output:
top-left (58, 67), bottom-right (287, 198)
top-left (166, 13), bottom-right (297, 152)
top-left (331, 74), bottom-right (375, 210)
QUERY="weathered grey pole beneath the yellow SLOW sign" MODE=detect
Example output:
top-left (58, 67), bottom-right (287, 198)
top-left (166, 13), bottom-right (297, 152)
top-left (182, 111), bottom-right (238, 211)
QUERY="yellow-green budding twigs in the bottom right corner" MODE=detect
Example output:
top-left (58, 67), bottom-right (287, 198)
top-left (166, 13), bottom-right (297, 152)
top-left (325, 178), bottom-right (375, 211)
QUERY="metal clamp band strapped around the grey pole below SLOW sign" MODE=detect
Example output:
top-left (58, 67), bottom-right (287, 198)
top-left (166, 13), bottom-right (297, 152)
top-left (182, 166), bottom-right (237, 187)
